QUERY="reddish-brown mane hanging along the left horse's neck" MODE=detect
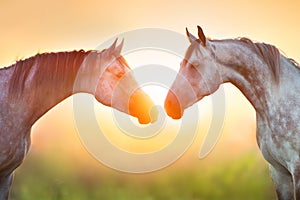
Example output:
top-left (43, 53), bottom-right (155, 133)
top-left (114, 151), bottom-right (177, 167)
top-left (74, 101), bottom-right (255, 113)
top-left (8, 50), bottom-right (89, 99)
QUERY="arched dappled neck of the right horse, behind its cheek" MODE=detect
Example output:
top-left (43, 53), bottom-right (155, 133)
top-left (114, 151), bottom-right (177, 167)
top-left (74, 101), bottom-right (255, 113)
top-left (214, 40), bottom-right (280, 115)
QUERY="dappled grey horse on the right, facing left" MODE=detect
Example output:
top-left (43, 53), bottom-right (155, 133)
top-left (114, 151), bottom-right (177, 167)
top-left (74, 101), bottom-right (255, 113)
top-left (164, 26), bottom-right (300, 200)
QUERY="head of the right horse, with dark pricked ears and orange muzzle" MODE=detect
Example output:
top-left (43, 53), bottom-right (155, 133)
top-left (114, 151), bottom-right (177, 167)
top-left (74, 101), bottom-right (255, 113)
top-left (165, 26), bottom-right (222, 119)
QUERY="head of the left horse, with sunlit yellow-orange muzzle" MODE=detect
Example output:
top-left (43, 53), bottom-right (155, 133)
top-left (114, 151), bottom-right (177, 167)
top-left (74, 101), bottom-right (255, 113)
top-left (94, 39), bottom-right (157, 124)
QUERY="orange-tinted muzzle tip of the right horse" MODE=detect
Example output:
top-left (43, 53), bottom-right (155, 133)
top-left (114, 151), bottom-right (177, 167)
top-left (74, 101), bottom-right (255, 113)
top-left (165, 91), bottom-right (182, 119)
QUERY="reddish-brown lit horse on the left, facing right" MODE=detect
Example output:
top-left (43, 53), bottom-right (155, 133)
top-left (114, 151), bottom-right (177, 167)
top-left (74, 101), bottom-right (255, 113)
top-left (0, 39), bottom-right (155, 200)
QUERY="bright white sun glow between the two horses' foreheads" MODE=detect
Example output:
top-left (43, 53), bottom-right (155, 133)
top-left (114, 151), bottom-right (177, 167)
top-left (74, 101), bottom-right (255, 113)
top-left (123, 48), bottom-right (182, 109)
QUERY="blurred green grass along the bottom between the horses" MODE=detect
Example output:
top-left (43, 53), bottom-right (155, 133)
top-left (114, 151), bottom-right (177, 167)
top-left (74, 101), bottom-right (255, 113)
top-left (11, 153), bottom-right (275, 200)
